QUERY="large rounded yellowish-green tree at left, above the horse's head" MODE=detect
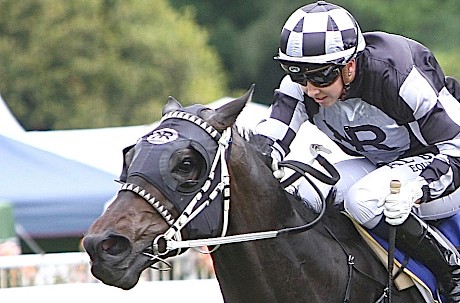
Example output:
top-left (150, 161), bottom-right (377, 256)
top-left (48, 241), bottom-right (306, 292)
top-left (0, 0), bottom-right (226, 129)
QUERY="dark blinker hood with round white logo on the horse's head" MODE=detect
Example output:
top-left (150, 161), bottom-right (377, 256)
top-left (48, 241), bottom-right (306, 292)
top-left (120, 106), bottom-right (222, 238)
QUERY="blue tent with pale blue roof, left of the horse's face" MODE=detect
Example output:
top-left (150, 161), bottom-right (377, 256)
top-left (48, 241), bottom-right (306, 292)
top-left (0, 135), bottom-right (121, 238)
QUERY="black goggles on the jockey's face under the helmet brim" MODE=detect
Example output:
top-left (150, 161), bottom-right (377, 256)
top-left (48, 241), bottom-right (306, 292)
top-left (280, 63), bottom-right (343, 87)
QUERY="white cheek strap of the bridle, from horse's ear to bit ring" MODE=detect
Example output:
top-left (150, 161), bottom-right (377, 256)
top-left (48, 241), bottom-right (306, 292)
top-left (152, 127), bottom-right (232, 256)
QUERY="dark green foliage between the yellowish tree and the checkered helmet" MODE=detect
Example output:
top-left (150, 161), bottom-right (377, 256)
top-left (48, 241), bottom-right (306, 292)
top-left (170, 0), bottom-right (305, 103)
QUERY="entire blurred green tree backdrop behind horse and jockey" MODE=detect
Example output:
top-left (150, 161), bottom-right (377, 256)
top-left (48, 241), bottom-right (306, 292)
top-left (0, 0), bottom-right (460, 129)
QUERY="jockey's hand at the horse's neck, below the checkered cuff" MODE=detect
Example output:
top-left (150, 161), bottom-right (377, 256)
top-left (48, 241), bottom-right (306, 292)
top-left (251, 134), bottom-right (284, 179)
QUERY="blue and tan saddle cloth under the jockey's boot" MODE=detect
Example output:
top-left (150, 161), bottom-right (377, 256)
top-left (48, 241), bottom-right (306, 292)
top-left (347, 213), bottom-right (460, 303)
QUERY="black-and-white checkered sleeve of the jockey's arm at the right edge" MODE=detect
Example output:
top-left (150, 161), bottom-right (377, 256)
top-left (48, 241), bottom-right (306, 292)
top-left (399, 59), bottom-right (460, 201)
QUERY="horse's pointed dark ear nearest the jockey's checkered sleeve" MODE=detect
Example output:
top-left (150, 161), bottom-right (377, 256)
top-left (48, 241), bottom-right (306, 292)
top-left (208, 84), bottom-right (255, 130)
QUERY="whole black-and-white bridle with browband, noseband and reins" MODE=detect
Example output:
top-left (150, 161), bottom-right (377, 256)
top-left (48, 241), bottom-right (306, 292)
top-left (119, 111), bottom-right (339, 267)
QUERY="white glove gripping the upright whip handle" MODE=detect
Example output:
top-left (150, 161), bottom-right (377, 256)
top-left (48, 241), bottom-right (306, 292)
top-left (378, 178), bottom-right (423, 225)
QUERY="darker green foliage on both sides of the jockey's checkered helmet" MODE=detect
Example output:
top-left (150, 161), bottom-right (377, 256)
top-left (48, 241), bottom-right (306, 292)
top-left (171, 0), bottom-right (460, 103)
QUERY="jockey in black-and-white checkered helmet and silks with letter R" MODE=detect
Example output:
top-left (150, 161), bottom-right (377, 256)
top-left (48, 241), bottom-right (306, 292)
top-left (256, 1), bottom-right (460, 302)
